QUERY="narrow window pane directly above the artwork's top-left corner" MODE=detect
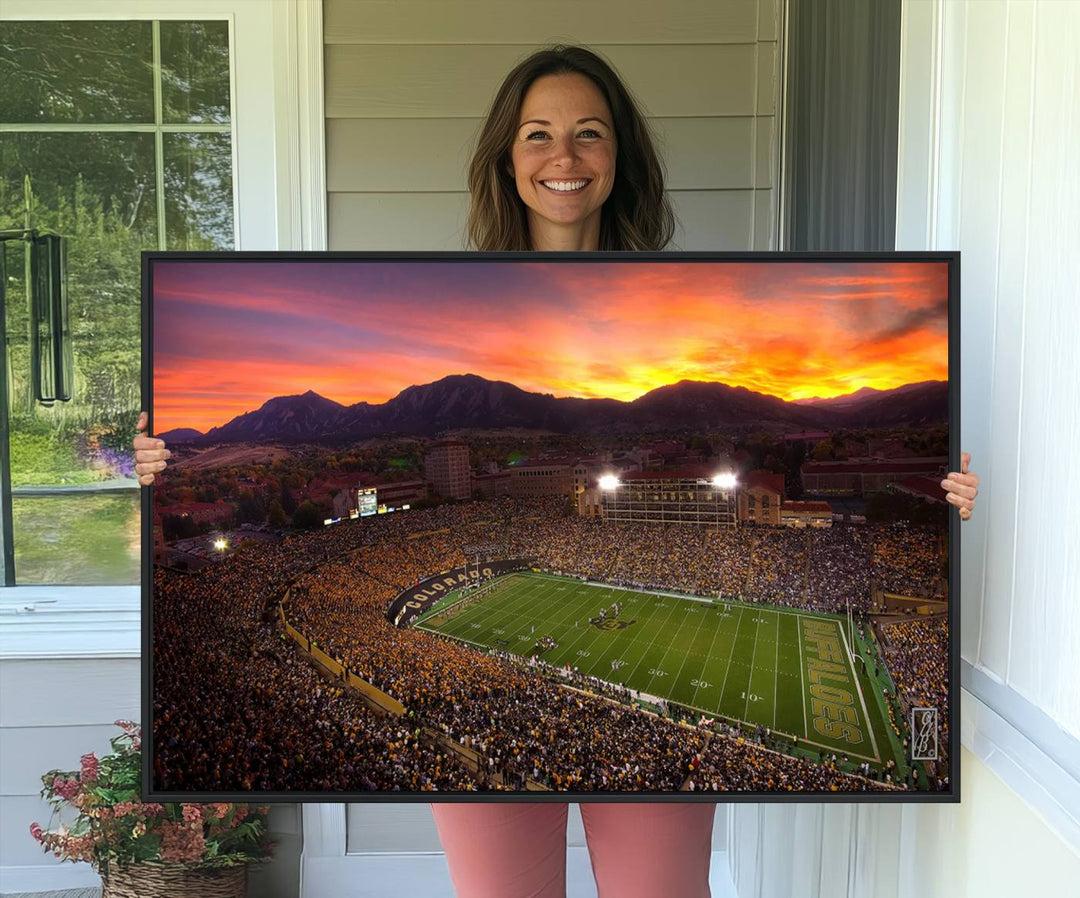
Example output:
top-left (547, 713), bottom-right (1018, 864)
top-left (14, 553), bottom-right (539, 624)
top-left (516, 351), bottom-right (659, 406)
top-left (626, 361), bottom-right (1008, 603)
top-left (164, 134), bottom-right (233, 250)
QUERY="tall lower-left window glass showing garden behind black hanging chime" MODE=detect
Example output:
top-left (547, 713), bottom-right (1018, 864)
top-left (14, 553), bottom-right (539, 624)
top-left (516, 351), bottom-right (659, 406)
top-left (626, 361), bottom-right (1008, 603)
top-left (0, 133), bottom-right (150, 585)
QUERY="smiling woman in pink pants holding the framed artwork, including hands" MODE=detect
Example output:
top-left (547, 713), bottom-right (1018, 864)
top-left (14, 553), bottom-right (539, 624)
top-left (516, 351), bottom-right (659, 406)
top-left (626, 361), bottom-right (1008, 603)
top-left (135, 46), bottom-right (978, 898)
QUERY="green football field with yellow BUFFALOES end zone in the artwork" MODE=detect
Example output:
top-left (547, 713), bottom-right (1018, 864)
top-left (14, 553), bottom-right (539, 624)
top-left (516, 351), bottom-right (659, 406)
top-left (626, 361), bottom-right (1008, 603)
top-left (417, 573), bottom-right (903, 764)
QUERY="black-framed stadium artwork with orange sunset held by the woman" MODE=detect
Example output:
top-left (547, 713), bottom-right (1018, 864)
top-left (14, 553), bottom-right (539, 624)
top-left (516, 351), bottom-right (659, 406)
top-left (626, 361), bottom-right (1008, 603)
top-left (143, 253), bottom-right (959, 802)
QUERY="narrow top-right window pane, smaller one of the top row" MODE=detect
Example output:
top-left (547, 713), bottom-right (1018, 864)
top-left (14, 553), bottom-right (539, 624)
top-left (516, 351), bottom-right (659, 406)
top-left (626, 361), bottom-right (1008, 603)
top-left (161, 22), bottom-right (229, 124)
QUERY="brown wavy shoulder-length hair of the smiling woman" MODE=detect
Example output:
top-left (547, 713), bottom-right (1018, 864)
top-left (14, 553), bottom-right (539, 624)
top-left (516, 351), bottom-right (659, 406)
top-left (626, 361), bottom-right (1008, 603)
top-left (468, 45), bottom-right (675, 252)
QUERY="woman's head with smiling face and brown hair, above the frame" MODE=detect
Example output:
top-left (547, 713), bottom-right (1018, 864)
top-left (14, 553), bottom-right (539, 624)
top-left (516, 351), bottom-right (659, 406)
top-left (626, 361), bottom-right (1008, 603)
top-left (469, 46), bottom-right (675, 251)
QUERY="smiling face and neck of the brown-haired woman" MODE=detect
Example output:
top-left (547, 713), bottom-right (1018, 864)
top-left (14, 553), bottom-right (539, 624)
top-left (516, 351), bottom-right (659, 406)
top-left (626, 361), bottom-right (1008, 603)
top-left (510, 75), bottom-right (616, 245)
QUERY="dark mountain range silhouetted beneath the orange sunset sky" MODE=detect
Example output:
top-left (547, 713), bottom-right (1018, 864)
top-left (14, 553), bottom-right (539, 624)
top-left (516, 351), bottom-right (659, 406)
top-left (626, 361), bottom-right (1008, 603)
top-left (158, 374), bottom-right (948, 444)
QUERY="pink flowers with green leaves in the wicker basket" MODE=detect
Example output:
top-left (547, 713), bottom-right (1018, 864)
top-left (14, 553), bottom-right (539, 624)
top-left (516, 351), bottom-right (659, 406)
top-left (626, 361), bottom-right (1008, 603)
top-left (30, 721), bottom-right (274, 875)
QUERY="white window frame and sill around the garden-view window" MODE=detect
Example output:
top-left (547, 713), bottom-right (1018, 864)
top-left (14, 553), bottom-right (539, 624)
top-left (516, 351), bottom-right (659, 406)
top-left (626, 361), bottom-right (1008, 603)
top-left (0, 0), bottom-right (326, 659)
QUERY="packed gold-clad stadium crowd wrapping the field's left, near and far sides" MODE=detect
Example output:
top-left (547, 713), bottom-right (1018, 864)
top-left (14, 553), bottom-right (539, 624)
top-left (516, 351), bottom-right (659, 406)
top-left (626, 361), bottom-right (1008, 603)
top-left (153, 499), bottom-right (944, 791)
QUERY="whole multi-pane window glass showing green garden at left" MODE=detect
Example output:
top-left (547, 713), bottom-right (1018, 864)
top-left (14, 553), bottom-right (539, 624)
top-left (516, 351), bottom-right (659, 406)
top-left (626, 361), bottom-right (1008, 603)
top-left (0, 19), bottom-right (235, 585)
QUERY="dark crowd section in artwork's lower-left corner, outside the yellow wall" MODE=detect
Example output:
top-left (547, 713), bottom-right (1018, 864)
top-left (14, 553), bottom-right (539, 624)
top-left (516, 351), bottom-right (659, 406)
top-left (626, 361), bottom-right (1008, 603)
top-left (153, 559), bottom-right (472, 791)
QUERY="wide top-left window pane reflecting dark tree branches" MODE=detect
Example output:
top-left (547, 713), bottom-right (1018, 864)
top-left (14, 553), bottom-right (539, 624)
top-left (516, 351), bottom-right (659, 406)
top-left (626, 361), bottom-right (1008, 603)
top-left (0, 22), bottom-right (153, 123)
